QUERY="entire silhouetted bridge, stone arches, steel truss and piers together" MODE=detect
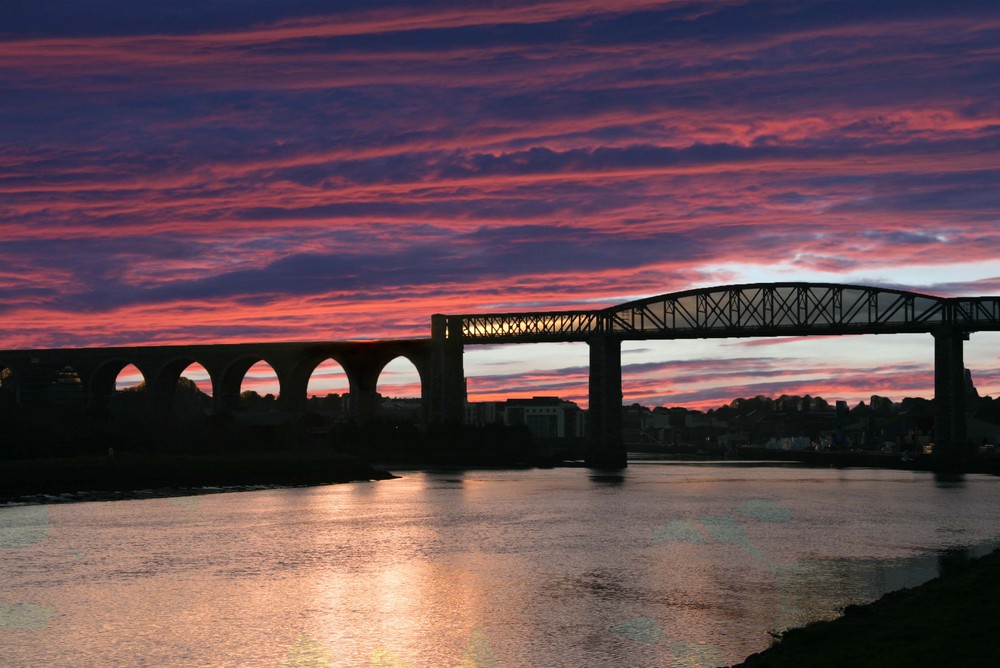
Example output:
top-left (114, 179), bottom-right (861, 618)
top-left (0, 283), bottom-right (1000, 468)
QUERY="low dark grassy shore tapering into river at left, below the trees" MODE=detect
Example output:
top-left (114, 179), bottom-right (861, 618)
top-left (0, 451), bottom-right (395, 503)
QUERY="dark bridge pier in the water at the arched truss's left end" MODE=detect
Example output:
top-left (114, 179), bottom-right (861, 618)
top-left (587, 334), bottom-right (627, 469)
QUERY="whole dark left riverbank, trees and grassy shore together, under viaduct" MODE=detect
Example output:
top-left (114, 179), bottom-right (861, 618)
top-left (0, 384), bottom-right (553, 500)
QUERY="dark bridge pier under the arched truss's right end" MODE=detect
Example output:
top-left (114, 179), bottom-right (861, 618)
top-left (933, 328), bottom-right (969, 466)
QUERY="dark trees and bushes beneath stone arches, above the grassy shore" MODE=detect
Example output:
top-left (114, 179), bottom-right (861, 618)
top-left (0, 377), bottom-right (556, 466)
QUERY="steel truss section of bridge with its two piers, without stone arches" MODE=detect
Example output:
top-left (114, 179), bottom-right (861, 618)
top-left (434, 283), bottom-right (1000, 466)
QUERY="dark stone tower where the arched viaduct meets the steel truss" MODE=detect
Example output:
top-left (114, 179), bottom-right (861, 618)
top-left (424, 315), bottom-right (466, 424)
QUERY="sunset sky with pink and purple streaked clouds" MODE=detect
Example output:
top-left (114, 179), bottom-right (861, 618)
top-left (0, 0), bottom-right (1000, 408)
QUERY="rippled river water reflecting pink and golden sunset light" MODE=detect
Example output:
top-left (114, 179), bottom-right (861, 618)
top-left (0, 464), bottom-right (1000, 668)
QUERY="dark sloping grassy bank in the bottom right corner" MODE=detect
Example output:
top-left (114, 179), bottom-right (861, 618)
top-left (733, 551), bottom-right (1000, 668)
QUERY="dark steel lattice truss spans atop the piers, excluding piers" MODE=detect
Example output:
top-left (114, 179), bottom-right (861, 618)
top-left (449, 283), bottom-right (1000, 343)
